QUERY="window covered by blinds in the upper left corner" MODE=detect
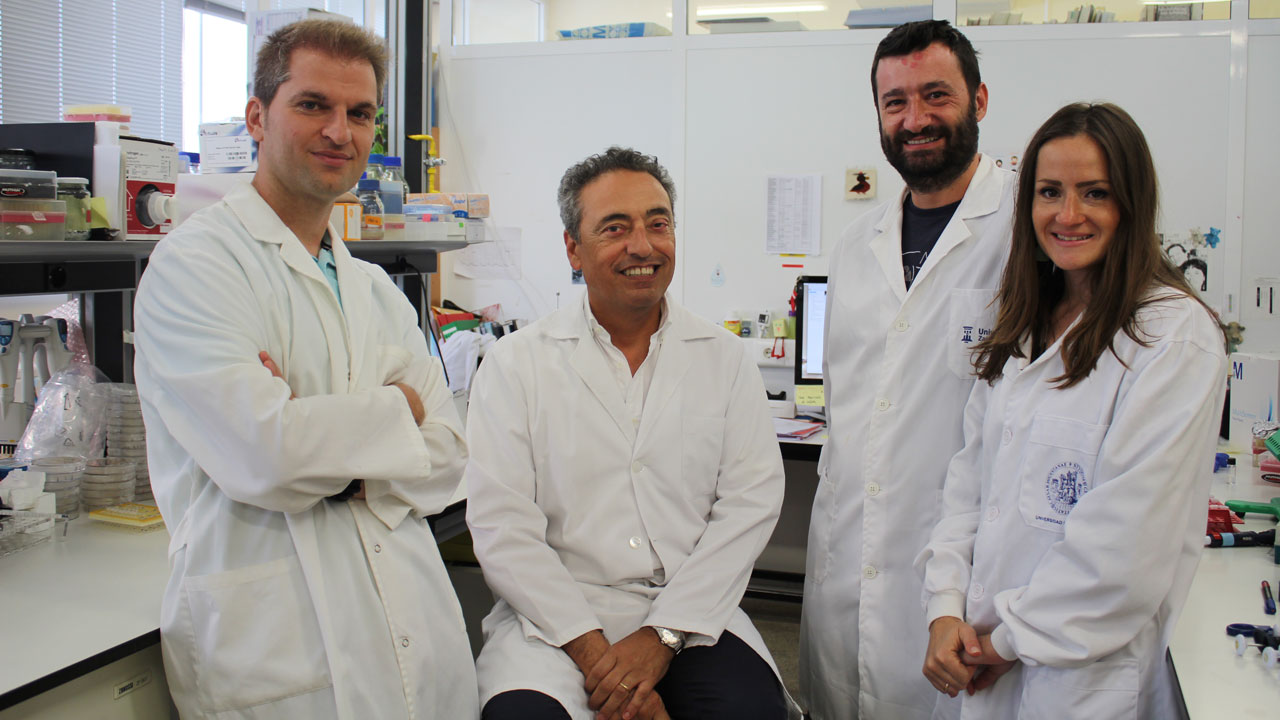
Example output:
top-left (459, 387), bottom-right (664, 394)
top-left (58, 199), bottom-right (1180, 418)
top-left (0, 0), bottom-right (182, 142)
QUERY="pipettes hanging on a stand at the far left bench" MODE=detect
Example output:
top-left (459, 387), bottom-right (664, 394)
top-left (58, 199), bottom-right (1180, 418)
top-left (0, 315), bottom-right (72, 455)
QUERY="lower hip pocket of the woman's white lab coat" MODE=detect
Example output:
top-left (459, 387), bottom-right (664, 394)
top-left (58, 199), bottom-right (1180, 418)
top-left (1018, 659), bottom-right (1139, 720)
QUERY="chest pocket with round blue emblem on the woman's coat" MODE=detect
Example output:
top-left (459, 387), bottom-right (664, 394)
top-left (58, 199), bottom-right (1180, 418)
top-left (1018, 415), bottom-right (1107, 533)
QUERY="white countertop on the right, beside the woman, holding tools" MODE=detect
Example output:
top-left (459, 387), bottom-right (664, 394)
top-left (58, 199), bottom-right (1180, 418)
top-left (1169, 455), bottom-right (1280, 720)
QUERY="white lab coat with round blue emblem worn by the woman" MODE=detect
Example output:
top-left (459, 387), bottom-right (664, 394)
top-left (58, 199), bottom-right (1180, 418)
top-left (918, 296), bottom-right (1226, 720)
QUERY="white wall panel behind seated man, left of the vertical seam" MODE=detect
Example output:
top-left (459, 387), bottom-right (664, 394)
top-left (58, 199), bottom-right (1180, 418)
top-left (440, 41), bottom-right (678, 320)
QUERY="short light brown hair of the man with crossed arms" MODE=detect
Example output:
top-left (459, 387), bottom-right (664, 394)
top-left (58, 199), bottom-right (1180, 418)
top-left (253, 20), bottom-right (387, 108)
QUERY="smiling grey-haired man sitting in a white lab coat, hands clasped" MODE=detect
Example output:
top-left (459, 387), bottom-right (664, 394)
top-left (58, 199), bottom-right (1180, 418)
top-left (466, 147), bottom-right (787, 720)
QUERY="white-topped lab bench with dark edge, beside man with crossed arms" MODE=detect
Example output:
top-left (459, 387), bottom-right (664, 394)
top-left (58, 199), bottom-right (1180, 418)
top-left (0, 483), bottom-right (466, 720)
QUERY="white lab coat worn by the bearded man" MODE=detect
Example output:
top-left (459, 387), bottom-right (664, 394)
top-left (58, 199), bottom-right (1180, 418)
top-left (800, 156), bottom-right (1016, 720)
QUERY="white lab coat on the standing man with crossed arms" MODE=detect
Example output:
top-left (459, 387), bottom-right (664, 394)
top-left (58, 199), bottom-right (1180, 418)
top-left (136, 186), bottom-right (479, 719)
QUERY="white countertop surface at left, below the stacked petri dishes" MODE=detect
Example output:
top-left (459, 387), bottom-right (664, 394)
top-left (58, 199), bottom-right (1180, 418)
top-left (0, 514), bottom-right (169, 694)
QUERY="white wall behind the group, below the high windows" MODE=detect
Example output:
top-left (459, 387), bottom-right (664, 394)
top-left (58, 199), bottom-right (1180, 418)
top-left (442, 20), bottom-right (1280, 350)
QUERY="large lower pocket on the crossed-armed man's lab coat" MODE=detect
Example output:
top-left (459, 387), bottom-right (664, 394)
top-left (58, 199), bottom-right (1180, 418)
top-left (183, 556), bottom-right (332, 712)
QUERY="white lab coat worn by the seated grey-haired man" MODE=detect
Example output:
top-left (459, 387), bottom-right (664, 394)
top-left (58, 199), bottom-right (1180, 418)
top-left (466, 294), bottom-right (783, 719)
